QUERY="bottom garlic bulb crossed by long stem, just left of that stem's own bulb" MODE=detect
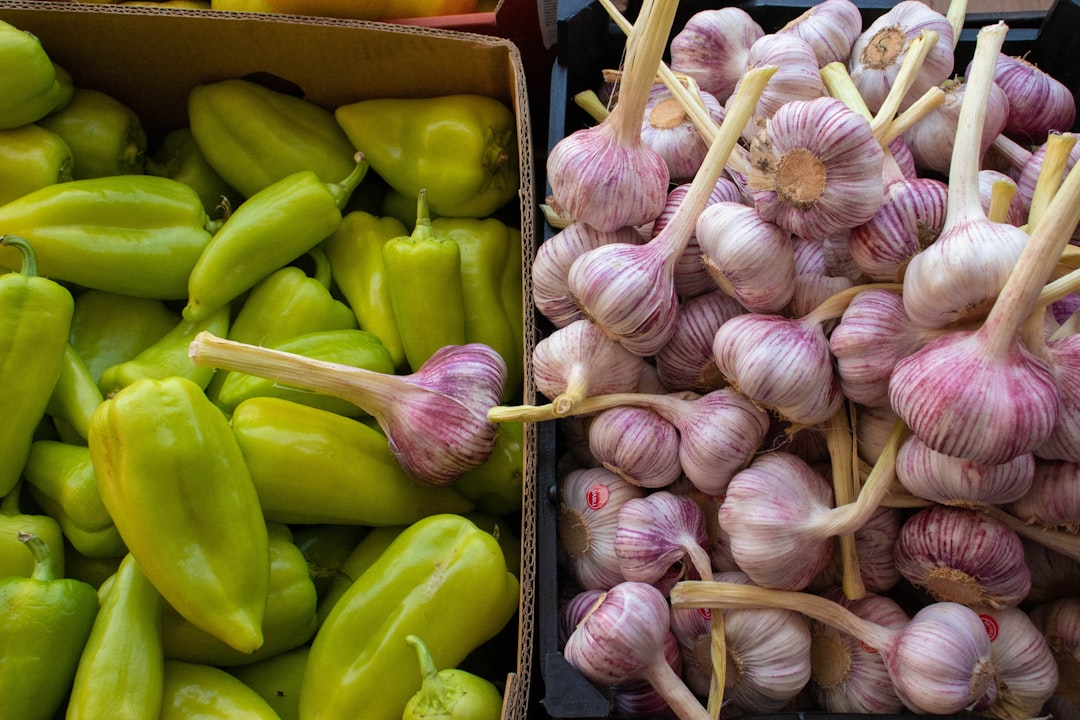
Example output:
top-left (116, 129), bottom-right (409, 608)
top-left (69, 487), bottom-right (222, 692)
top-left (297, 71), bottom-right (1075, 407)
top-left (810, 588), bottom-right (910, 715)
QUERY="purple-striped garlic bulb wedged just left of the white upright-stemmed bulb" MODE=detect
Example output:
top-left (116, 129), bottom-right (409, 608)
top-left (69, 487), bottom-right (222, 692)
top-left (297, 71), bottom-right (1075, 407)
top-left (848, 178), bottom-right (948, 283)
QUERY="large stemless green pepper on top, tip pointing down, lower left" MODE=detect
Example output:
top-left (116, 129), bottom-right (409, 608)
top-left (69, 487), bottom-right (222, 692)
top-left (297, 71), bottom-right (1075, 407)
top-left (90, 377), bottom-right (270, 652)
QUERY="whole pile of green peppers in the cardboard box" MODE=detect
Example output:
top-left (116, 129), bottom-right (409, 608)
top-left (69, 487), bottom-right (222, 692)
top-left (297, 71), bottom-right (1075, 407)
top-left (0, 22), bottom-right (525, 720)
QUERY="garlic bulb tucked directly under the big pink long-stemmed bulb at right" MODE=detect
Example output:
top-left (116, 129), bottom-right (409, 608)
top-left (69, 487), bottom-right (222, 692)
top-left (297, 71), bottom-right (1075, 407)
top-left (896, 435), bottom-right (1036, 508)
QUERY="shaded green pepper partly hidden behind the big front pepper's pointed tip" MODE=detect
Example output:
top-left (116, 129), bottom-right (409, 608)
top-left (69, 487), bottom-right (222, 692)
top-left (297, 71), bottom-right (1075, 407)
top-left (161, 522), bottom-right (318, 667)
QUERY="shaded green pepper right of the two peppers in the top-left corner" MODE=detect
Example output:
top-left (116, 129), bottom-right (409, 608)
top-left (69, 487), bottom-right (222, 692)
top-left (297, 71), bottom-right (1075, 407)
top-left (38, 87), bottom-right (147, 180)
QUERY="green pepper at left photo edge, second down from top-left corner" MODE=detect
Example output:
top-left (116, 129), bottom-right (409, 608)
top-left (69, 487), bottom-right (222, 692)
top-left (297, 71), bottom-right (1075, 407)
top-left (0, 123), bottom-right (71, 205)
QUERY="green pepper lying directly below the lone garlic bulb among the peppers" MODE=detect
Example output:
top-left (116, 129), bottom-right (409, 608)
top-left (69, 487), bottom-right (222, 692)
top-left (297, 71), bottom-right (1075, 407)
top-left (231, 397), bottom-right (473, 527)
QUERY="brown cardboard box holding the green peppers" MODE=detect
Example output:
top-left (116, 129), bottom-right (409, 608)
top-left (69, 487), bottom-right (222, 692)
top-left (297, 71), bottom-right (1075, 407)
top-left (0, 1), bottom-right (537, 720)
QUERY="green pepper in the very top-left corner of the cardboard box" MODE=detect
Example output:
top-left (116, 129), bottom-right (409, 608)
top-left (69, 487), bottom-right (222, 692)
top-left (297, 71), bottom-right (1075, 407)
top-left (0, 21), bottom-right (63, 128)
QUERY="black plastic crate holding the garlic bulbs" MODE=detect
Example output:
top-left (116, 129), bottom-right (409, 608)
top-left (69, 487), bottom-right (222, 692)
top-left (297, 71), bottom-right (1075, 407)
top-left (534, 0), bottom-right (1080, 720)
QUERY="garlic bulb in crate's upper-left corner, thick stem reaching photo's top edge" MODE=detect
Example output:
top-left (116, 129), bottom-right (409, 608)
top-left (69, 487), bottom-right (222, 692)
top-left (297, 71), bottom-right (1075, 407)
top-left (548, 0), bottom-right (678, 232)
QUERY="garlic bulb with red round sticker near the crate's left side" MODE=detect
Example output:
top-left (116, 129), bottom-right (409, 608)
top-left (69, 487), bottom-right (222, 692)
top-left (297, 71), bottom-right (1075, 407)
top-left (557, 467), bottom-right (645, 590)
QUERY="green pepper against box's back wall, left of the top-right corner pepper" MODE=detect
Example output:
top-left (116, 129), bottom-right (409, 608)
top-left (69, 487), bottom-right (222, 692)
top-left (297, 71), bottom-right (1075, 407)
top-left (188, 79), bottom-right (355, 198)
